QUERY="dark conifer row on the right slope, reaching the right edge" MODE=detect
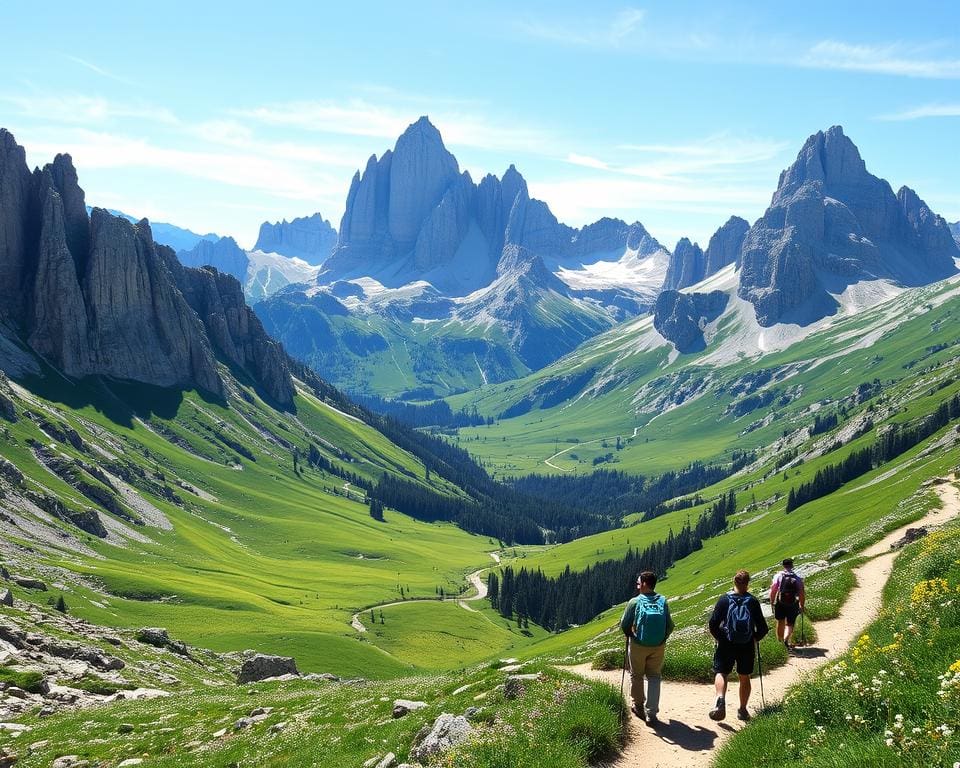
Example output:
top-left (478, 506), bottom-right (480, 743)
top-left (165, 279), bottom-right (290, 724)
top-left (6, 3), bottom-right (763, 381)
top-left (787, 395), bottom-right (960, 512)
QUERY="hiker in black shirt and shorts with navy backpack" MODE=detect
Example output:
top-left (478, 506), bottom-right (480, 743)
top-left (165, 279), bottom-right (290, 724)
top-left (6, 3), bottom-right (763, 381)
top-left (710, 570), bottom-right (770, 720)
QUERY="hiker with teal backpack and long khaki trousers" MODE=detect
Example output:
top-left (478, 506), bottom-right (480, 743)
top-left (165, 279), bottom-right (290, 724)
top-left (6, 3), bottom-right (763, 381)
top-left (620, 571), bottom-right (673, 726)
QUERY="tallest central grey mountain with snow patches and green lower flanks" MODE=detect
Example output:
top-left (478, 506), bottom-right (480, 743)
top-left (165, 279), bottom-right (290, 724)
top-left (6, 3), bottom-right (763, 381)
top-left (257, 117), bottom-right (669, 402)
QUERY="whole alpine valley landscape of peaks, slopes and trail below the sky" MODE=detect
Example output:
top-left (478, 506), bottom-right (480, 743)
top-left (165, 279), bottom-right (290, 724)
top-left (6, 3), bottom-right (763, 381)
top-left (0, 117), bottom-right (960, 768)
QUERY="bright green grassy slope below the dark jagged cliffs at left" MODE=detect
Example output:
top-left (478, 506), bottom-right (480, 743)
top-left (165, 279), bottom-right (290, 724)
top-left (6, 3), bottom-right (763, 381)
top-left (2, 376), bottom-right (506, 676)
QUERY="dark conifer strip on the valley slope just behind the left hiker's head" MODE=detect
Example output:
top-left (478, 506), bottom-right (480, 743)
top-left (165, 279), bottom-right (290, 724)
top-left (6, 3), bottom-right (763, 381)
top-left (487, 491), bottom-right (736, 632)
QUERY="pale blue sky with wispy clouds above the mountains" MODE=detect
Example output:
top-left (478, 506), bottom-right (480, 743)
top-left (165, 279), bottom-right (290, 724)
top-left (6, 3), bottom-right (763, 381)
top-left (0, 1), bottom-right (960, 248)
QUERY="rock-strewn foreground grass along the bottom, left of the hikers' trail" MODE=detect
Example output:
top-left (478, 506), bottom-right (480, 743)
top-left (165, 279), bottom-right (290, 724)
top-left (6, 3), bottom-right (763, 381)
top-left (0, 666), bottom-right (623, 768)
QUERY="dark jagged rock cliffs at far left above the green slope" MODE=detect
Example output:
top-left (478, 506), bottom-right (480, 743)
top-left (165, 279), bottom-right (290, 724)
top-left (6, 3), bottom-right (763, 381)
top-left (0, 129), bottom-right (293, 404)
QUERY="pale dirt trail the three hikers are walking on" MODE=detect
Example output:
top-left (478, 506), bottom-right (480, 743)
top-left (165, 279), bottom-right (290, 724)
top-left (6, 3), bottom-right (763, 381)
top-left (570, 476), bottom-right (960, 768)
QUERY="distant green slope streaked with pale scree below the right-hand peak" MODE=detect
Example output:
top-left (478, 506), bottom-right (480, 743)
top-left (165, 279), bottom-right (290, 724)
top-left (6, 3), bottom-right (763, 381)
top-left (449, 285), bottom-right (957, 475)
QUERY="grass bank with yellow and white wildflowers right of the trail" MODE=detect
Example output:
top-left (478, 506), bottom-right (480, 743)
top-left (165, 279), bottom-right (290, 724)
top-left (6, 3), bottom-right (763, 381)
top-left (716, 524), bottom-right (960, 768)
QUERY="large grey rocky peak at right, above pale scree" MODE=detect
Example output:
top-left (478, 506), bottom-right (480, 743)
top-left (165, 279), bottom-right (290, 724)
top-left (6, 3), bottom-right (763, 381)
top-left (739, 126), bottom-right (960, 326)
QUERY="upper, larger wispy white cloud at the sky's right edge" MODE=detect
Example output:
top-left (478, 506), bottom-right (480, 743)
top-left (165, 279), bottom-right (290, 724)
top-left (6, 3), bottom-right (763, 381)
top-left (797, 40), bottom-right (960, 79)
